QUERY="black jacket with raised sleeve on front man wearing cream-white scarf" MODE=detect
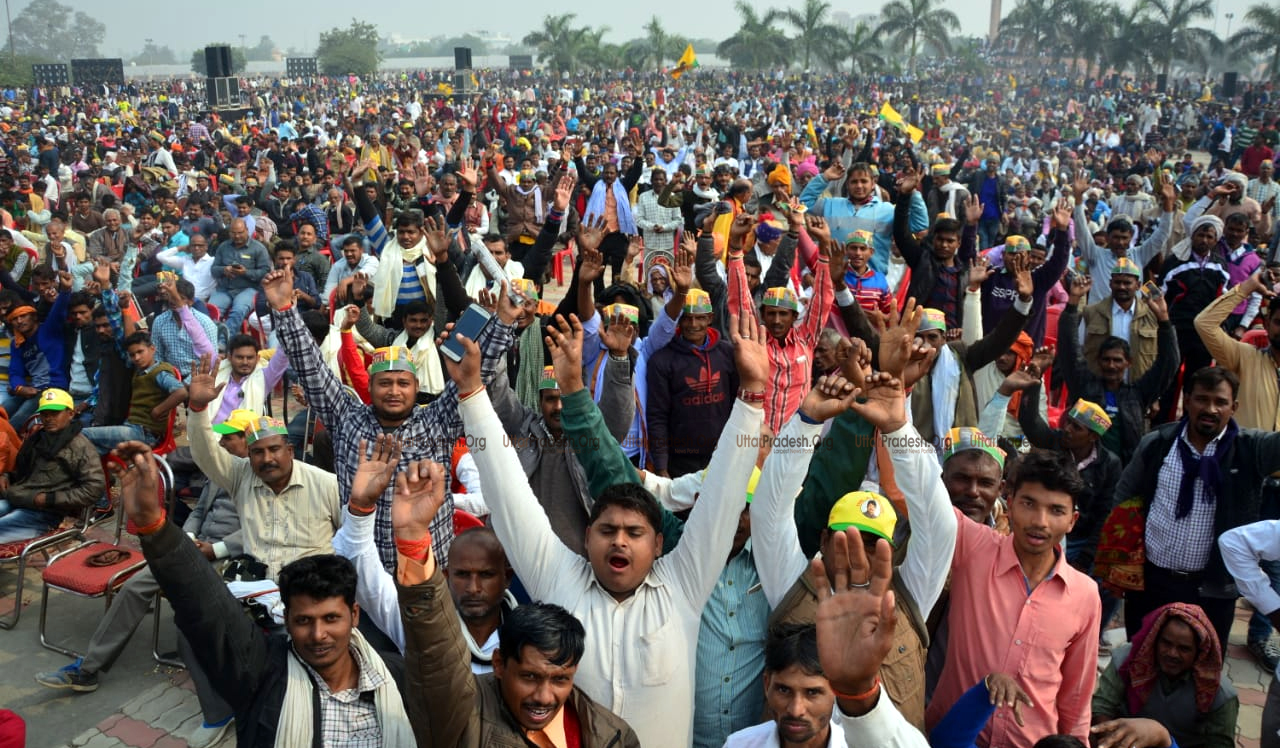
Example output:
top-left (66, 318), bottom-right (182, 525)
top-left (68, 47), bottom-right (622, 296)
top-left (141, 523), bottom-right (403, 748)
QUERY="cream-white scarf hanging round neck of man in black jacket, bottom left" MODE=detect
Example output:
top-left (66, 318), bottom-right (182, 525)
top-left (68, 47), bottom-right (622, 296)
top-left (275, 629), bottom-right (415, 748)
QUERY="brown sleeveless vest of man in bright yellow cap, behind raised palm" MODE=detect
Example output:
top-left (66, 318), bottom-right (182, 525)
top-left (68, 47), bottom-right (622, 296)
top-left (769, 574), bottom-right (929, 730)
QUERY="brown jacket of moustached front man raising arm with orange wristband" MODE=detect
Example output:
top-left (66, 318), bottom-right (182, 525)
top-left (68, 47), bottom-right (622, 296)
top-left (397, 567), bottom-right (640, 748)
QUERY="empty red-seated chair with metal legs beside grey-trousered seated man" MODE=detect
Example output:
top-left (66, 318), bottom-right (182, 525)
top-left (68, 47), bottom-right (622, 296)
top-left (40, 456), bottom-right (173, 657)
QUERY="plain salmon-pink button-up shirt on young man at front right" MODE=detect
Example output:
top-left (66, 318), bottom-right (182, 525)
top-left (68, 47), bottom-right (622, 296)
top-left (924, 511), bottom-right (1102, 748)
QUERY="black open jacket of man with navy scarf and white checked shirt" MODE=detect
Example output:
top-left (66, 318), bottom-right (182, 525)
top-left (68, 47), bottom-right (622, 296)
top-left (1112, 421), bottom-right (1280, 598)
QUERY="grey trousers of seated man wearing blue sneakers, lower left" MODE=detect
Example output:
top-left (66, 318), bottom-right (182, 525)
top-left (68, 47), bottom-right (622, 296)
top-left (81, 567), bottom-right (232, 725)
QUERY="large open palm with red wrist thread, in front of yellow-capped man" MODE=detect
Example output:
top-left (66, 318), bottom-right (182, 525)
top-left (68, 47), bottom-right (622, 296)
top-left (809, 528), bottom-right (897, 716)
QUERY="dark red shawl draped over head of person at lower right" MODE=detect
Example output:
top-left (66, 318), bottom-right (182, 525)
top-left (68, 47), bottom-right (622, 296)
top-left (1120, 602), bottom-right (1222, 715)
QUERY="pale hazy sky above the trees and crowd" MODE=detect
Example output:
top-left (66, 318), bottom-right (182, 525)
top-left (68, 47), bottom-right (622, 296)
top-left (37, 0), bottom-right (1239, 59)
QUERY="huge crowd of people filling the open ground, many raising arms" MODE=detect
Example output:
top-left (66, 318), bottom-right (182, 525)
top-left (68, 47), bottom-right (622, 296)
top-left (0, 67), bottom-right (1280, 748)
